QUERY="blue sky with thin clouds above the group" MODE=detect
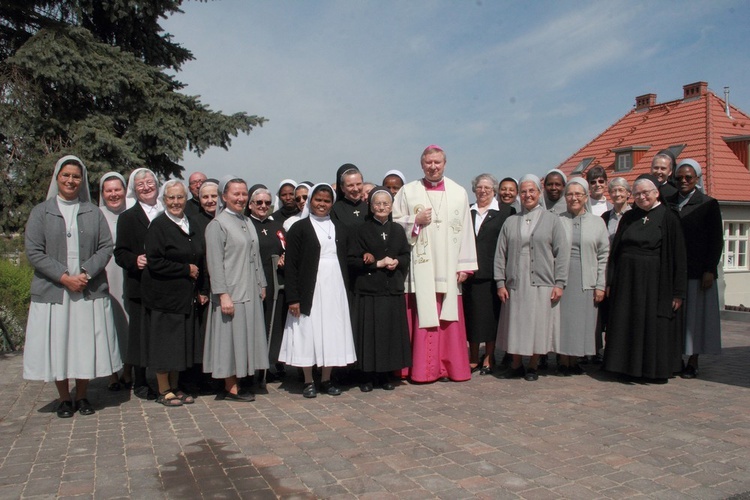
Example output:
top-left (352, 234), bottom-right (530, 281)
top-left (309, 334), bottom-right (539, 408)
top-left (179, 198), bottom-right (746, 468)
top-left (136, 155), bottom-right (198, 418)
top-left (162, 0), bottom-right (750, 191)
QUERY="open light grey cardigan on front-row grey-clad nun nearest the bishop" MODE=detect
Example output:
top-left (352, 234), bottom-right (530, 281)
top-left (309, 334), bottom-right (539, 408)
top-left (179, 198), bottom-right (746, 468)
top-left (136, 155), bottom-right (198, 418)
top-left (494, 210), bottom-right (570, 290)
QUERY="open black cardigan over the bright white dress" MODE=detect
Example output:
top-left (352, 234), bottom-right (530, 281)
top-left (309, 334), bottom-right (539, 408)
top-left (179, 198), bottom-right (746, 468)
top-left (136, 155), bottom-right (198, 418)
top-left (284, 218), bottom-right (349, 316)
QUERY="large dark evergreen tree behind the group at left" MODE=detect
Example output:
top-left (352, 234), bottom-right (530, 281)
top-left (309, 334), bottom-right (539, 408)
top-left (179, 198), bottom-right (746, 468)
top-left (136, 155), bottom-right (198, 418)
top-left (0, 0), bottom-right (265, 233)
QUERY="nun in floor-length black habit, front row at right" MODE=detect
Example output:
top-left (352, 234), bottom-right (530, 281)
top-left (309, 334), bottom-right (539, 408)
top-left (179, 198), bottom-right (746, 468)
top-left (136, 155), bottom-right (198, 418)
top-left (604, 174), bottom-right (687, 383)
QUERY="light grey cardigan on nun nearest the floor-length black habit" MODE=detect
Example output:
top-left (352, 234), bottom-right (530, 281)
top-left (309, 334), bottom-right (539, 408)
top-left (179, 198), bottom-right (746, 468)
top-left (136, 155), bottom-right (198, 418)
top-left (560, 212), bottom-right (609, 291)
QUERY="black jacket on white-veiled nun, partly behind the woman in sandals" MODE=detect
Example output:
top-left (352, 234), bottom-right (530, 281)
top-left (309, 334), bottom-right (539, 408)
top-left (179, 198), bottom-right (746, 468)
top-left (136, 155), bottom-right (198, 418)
top-left (114, 202), bottom-right (149, 299)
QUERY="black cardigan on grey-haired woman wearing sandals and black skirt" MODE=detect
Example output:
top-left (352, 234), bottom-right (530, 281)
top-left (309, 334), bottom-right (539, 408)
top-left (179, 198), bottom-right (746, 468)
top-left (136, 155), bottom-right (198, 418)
top-left (141, 214), bottom-right (207, 314)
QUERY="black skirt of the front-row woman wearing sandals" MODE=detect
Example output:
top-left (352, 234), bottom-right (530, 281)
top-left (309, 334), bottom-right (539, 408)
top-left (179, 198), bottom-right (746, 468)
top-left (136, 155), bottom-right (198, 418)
top-left (143, 307), bottom-right (196, 372)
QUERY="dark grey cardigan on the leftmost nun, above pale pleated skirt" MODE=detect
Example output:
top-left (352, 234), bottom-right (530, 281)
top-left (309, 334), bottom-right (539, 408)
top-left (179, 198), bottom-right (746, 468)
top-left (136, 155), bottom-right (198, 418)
top-left (26, 197), bottom-right (114, 304)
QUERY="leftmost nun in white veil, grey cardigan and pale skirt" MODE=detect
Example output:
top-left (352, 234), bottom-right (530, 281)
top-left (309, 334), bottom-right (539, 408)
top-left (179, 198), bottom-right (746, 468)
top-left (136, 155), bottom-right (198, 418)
top-left (23, 156), bottom-right (122, 418)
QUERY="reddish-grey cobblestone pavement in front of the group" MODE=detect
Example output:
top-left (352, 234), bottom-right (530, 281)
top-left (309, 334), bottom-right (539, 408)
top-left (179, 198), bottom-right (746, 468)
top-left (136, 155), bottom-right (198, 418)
top-left (0, 321), bottom-right (750, 499)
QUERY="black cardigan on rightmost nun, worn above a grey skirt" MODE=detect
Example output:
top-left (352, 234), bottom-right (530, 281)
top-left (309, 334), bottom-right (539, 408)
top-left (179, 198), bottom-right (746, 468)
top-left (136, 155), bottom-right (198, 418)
top-left (667, 190), bottom-right (724, 279)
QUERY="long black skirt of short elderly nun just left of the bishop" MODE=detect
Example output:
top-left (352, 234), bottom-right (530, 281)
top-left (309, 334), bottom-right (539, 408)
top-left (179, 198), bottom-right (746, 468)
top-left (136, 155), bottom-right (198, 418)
top-left (352, 295), bottom-right (411, 372)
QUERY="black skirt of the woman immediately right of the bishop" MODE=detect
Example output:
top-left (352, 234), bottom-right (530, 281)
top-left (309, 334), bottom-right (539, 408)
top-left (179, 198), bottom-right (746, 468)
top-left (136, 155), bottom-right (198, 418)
top-left (462, 279), bottom-right (500, 344)
